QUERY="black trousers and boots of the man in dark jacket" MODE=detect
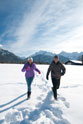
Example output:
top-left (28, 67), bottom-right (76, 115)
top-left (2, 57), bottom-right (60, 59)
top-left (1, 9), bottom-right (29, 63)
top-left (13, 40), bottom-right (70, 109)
top-left (52, 78), bottom-right (60, 99)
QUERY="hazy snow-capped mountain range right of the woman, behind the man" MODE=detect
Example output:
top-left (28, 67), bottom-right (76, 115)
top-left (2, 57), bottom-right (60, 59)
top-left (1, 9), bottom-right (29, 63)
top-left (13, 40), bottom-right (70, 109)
top-left (32, 50), bottom-right (83, 63)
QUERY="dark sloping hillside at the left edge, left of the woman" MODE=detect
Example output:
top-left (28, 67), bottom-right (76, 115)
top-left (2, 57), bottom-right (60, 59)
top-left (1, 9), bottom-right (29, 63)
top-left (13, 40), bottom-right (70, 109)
top-left (0, 48), bottom-right (24, 63)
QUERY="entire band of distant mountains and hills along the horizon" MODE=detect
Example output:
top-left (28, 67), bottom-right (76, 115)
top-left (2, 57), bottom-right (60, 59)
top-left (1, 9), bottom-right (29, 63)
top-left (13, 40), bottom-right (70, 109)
top-left (0, 48), bottom-right (83, 64)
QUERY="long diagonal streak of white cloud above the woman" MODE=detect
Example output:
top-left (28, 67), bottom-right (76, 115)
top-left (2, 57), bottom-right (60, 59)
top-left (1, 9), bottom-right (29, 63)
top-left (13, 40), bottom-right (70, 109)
top-left (7, 0), bottom-right (49, 52)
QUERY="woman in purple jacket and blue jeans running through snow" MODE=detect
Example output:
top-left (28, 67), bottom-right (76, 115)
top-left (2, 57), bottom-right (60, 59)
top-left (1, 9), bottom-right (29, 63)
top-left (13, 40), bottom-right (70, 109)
top-left (22, 57), bottom-right (41, 99)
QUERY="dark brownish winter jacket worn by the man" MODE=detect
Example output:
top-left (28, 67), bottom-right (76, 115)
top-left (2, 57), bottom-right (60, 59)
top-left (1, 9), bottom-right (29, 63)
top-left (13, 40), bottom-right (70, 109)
top-left (46, 61), bottom-right (66, 79)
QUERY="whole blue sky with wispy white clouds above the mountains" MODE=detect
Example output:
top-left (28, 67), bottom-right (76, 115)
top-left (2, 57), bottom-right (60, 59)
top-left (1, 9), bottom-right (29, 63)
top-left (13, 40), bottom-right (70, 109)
top-left (0, 0), bottom-right (83, 56)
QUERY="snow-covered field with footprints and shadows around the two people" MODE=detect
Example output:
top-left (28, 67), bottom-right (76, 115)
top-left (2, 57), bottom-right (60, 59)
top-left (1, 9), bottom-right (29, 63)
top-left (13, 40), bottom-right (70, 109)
top-left (0, 64), bottom-right (83, 124)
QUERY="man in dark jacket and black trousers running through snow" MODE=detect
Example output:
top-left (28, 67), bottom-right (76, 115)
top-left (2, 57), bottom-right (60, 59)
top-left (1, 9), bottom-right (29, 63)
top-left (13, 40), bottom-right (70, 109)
top-left (46, 56), bottom-right (66, 100)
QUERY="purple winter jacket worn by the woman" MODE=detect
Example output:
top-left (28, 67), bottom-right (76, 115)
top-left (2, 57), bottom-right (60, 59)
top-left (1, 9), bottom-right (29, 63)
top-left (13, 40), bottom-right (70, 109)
top-left (22, 62), bottom-right (40, 77)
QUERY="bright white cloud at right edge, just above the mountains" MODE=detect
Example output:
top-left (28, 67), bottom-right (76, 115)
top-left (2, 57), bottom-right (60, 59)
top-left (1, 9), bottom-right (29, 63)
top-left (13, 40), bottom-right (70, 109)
top-left (52, 26), bottom-right (83, 52)
